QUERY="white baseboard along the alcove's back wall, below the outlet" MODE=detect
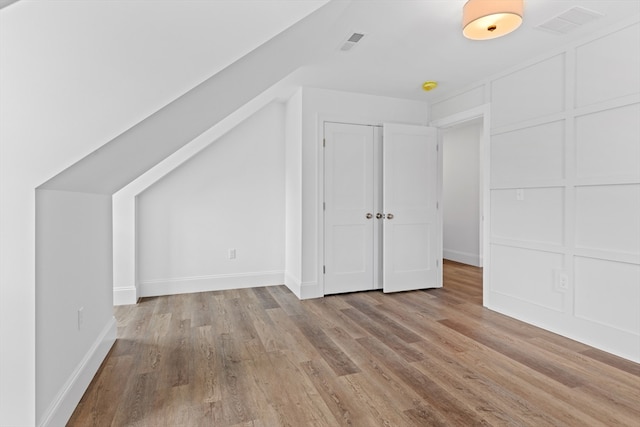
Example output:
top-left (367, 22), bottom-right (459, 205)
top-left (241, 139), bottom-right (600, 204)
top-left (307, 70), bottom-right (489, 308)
top-left (138, 271), bottom-right (284, 297)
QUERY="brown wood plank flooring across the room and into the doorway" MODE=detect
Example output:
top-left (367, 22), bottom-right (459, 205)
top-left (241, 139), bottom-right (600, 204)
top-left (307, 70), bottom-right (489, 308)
top-left (68, 262), bottom-right (640, 427)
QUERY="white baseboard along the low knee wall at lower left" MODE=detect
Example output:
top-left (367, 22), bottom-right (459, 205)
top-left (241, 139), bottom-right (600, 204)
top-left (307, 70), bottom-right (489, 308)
top-left (38, 317), bottom-right (117, 427)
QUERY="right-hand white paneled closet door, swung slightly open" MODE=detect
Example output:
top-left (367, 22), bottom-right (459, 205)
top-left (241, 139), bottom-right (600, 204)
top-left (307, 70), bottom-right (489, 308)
top-left (382, 124), bottom-right (442, 292)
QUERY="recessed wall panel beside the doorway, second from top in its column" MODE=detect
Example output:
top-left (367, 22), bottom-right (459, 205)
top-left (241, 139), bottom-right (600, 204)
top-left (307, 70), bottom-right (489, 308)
top-left (491, 121), bottom-right (565, 186)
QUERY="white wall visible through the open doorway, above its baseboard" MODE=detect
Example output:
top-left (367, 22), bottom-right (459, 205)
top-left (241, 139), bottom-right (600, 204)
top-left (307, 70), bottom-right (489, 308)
top-left (442, 119), bottom-right (482, 266)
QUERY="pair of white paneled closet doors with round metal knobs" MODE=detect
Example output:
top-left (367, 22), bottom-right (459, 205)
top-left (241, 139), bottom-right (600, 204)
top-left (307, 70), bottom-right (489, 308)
top-left (324, 123), bottom-right (442, 294)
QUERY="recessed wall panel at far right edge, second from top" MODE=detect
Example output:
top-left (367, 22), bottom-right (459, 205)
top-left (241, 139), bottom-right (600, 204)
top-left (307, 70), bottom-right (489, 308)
top-left (576, 104), bottom-right (640, 180)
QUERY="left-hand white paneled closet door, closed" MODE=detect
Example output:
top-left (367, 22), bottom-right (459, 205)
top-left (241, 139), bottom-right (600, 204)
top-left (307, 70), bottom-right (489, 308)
top-left (324, 123), bottom-right (381, 294)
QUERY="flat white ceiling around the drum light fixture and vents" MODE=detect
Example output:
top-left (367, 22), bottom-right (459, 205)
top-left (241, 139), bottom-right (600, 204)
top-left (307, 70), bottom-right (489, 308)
top-left (295, 0), bottom-right (640, 101)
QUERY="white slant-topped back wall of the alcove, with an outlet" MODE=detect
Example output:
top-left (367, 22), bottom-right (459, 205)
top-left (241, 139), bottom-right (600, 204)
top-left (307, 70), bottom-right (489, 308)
top-left (136, 102), bottom-right (285, 296)
